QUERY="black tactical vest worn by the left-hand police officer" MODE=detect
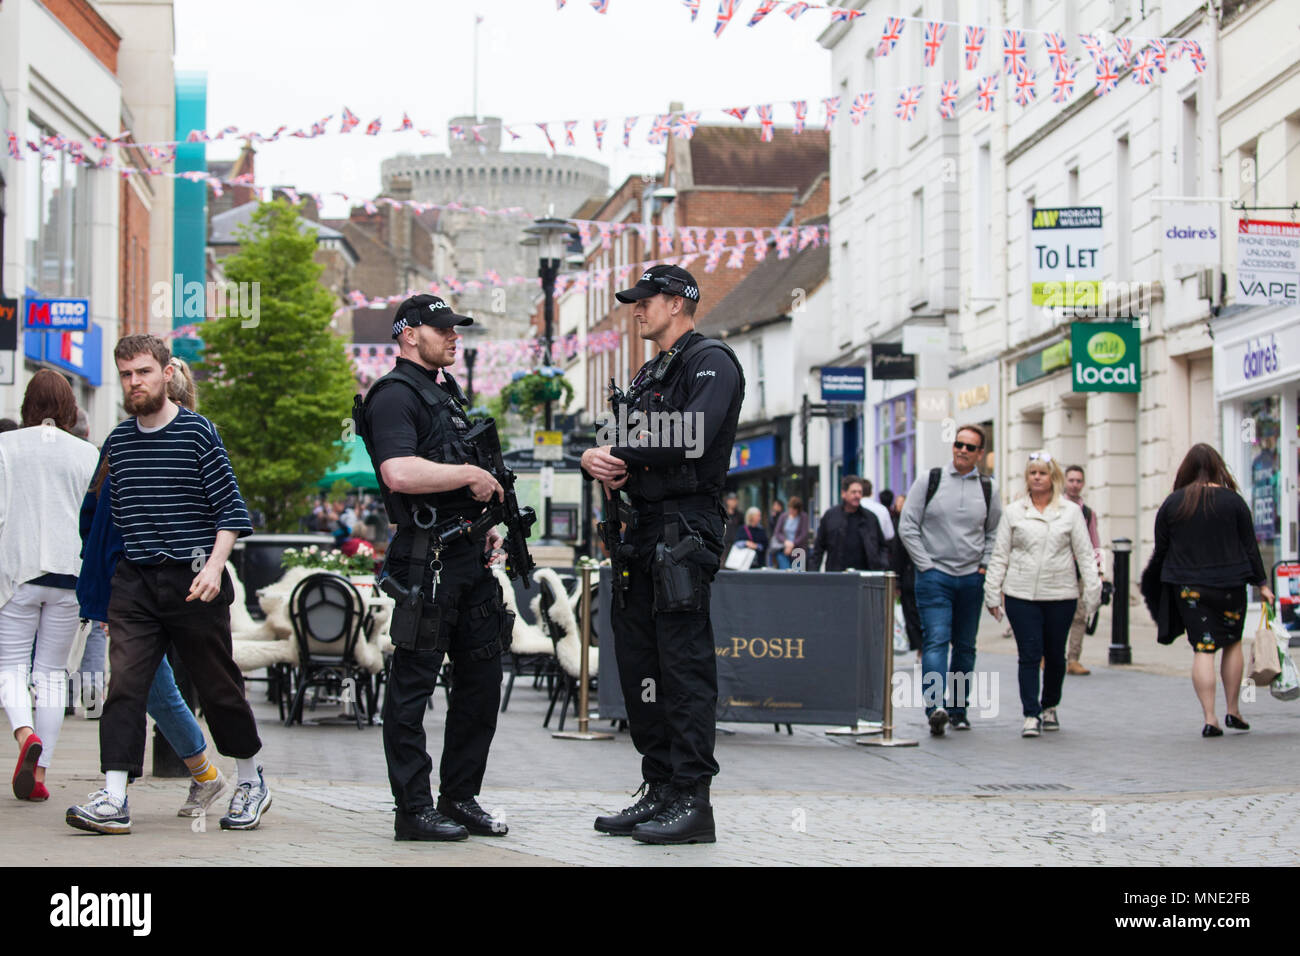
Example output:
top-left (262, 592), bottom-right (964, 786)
top-left (352, 364), bottom-right (482, 527)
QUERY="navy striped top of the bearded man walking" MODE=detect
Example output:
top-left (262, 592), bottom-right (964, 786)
top-left (104, 408), bottom-right (252, 564)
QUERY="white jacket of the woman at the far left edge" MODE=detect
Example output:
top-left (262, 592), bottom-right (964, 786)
top-left (0, 425), bottom-right (99, 605)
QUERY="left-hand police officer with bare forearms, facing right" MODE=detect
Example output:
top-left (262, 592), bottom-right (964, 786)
top-left (356, 295), bottom-right (512, 840)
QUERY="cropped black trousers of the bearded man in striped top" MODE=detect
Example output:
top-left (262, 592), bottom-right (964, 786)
top-left (99, 558), bottom-right (261, 777)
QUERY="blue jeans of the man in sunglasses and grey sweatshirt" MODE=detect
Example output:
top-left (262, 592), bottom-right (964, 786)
top-left (915, 567), bottom-right (984, 718)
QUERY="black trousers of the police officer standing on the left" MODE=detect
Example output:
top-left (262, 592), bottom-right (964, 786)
top-left (384, 546), bottom-right (504, 813)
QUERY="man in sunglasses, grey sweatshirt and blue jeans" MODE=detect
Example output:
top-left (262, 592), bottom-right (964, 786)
top-left (898, 425), bottom-right (1002, 736)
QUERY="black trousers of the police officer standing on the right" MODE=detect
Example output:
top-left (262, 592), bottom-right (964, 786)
top-left (610, 516), bottom-right (720, 788)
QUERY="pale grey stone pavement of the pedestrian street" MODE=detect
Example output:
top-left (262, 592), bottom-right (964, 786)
top-left (10, 647), bottom-right (1300, 866)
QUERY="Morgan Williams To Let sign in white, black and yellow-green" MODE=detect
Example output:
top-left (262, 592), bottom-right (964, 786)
top-left (1030, 206), bottom-right (1105, 308)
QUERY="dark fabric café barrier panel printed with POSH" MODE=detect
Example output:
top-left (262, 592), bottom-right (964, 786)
top-left (593, 567), bottom-right (893, 724)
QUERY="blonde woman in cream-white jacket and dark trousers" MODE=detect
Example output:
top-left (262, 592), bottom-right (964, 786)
top-left (984, 451), bottom-right (1101, 737)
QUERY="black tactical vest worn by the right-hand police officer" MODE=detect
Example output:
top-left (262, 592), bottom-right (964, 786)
top-left (624, 332), bottom-right (745, 502)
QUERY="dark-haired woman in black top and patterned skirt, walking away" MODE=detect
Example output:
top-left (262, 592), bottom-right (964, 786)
top-left (1143, 444), bottom-right (1273, 737)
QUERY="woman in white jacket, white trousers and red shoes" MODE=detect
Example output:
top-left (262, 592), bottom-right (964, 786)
top-left (0, 368), bottom-right (99, 800)
